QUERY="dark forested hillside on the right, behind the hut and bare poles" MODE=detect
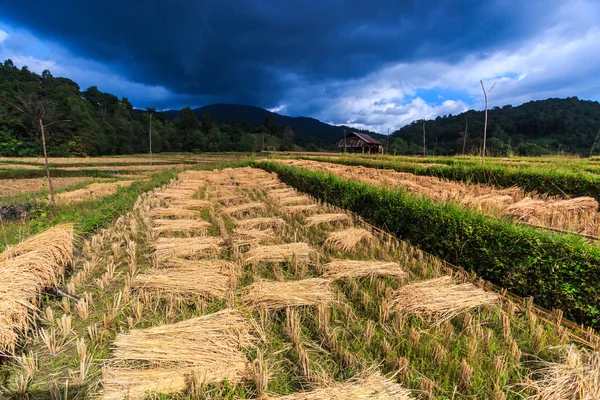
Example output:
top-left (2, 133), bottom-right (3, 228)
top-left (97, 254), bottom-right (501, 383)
top-left (390, 97), bottom-right (600, 156)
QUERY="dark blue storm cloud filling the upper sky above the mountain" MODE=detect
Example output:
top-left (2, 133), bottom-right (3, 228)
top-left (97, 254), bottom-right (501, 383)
top-left (0, 0), bottom-right (552, 107)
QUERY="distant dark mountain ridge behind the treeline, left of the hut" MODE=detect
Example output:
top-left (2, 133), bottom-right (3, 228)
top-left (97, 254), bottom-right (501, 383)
top-left (166, 104), bottom-right (385, 146)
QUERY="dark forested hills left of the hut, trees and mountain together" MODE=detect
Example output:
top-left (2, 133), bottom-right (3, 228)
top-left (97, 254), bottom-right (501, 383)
top-left (0, 60), bottom-right (380, 156)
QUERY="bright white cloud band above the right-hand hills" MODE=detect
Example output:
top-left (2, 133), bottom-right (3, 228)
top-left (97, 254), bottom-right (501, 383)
top-left (286, 12), bottom-right (600, 133)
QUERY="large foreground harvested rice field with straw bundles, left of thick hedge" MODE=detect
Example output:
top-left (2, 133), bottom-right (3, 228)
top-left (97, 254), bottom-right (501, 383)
top-left (0, 167), bottom-right (600, 400)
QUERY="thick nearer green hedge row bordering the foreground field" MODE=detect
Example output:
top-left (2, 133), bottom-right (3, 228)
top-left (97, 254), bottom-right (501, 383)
top-left (256, 162), bottom-right (600, 327)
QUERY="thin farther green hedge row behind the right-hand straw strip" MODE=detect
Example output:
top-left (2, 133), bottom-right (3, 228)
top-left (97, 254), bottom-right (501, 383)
top-left (302, 157), bottom-right (600, 201)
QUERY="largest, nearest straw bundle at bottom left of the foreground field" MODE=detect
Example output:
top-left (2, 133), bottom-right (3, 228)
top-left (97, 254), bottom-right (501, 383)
top-left (102, 309), bottom-right (254, 400)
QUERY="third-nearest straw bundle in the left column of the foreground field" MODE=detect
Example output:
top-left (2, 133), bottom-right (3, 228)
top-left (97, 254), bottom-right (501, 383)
top-left (153, 237), bottom-right (223, 261)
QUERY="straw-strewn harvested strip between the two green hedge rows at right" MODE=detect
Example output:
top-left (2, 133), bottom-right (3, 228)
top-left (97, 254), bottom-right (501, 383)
top-left (277, 159), bottom-right (600, 240)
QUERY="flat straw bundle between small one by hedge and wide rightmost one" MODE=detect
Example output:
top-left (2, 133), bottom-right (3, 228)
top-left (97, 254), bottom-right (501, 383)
top-left (322, 260), bottom-right (406, 280)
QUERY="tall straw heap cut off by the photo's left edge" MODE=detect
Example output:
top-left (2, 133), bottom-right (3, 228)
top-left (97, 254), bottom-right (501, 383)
top-left (0, 225), bottom-right (73, 353)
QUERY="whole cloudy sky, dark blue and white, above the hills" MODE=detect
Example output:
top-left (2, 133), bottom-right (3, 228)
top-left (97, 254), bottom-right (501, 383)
top-left (0, 0), bottom-right (600, 133)
